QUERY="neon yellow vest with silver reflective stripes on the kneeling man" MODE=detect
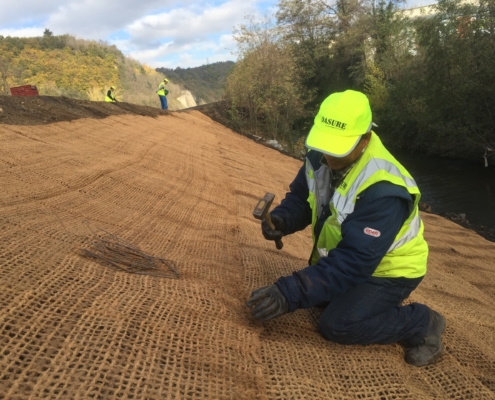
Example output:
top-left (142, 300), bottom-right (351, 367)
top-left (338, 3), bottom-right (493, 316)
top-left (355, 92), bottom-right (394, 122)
top-left (306, 133), bottom-right (428, 277)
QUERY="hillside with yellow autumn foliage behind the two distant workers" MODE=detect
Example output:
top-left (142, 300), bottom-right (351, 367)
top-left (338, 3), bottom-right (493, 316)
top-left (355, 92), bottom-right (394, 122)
top-left (0, 31), bottom-right (195, 110)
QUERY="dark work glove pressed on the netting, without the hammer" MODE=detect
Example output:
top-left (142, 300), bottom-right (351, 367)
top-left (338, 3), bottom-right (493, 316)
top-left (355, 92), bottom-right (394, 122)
top-left (246, 285), bottom-right (289, 321)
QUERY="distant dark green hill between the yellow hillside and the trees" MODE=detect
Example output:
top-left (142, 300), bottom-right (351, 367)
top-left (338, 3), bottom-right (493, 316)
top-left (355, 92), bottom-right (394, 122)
top-left (156, 61), bottom-right (235, 104)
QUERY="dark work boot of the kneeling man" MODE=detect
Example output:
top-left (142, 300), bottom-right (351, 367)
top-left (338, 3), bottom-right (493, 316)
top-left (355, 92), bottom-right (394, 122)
top-left (405, 310), bottom-right (445, 367)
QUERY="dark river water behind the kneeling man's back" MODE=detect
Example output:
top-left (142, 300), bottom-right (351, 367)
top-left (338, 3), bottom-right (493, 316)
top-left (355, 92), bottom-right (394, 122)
top-left (391, 150), bottom-right (495, 229)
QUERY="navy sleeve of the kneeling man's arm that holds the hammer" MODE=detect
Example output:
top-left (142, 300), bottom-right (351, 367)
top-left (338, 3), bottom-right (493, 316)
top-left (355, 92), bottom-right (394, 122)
top-left (271, 164), bottom-right (311, 235)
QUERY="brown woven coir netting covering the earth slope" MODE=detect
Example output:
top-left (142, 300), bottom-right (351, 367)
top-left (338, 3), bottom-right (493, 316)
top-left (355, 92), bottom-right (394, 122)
top-left (0, 111), bottom-right (495, 400)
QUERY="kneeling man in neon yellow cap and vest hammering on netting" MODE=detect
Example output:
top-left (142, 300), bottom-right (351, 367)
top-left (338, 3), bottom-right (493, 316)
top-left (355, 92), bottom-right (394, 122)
top-left (247, 90), bottom-right (445, 366)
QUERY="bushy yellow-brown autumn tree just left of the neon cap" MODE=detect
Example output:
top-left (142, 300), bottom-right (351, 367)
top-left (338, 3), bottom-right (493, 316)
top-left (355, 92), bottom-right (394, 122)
top-left (225, 19), bottom-right (311, 146)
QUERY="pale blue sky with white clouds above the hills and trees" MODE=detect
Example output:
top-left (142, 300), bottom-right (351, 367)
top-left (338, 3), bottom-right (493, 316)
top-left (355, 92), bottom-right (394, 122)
top-left (0, 0), bottom-right (433, 68)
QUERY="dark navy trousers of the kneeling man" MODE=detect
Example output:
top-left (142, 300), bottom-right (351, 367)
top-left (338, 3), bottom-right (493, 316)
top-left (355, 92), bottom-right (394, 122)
top-left (319, 277), bottom-right (430, 346)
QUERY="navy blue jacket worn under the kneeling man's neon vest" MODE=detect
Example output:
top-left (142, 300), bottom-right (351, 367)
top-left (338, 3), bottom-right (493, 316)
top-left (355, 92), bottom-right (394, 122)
top-left (271, 151), bottom-right (413, 311)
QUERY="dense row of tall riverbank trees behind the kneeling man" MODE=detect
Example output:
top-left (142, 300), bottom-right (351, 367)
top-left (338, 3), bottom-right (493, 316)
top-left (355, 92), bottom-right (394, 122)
top-left (223, 0), bottom-right (495, 159)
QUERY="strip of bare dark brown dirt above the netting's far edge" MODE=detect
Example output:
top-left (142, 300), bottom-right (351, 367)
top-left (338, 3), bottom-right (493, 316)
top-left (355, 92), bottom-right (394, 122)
top-left (0, 96), bottom-right (168, 125)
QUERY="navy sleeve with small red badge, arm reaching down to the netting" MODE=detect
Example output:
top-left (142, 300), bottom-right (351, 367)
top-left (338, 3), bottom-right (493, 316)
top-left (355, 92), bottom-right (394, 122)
top-left (276, 182), bottom-right (412, 311)
